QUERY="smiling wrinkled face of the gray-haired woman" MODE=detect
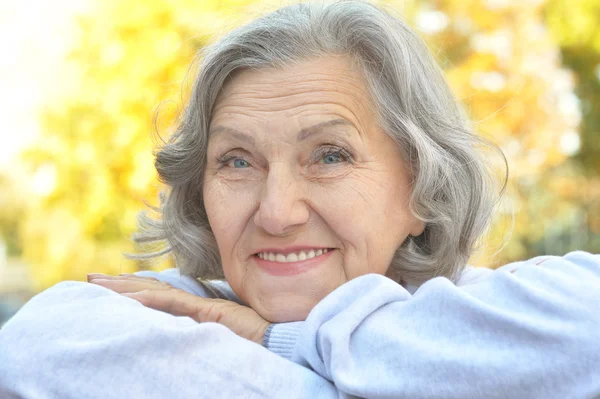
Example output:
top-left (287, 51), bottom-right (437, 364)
top-left (203, 56), bottom-right (424, 322)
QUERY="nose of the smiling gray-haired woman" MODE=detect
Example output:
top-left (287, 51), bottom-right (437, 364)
top-left (254, 164), bottom-right (309, 236)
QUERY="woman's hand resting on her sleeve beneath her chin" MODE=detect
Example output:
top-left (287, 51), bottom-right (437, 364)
top-left (88, 274), bottom-right (270, 345)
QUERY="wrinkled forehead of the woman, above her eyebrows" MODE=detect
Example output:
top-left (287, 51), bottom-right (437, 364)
top-left (213, 56), bottom-right (372, 123)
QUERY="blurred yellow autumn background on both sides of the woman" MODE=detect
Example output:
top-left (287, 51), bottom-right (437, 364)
top-left (0, 0), bottom-right (600, 325)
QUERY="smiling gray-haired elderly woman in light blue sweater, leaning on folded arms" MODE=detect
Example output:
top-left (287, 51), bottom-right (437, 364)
top-left (0, 1), bottom-right (600, 399)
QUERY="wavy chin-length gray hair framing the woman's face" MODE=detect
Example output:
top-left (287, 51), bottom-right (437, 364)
top-left (129, 0), bottom-right (508, 285)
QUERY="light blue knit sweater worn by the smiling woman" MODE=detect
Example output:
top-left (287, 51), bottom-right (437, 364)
top-left (0, 252), bottom-right (600, 399)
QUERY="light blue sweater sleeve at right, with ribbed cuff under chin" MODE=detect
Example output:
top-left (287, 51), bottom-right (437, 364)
top-left (269, 251), bottom-right (600, 399)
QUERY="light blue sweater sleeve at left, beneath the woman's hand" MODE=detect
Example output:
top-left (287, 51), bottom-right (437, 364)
top-left (0, 281), bottom-right (349, 399)
